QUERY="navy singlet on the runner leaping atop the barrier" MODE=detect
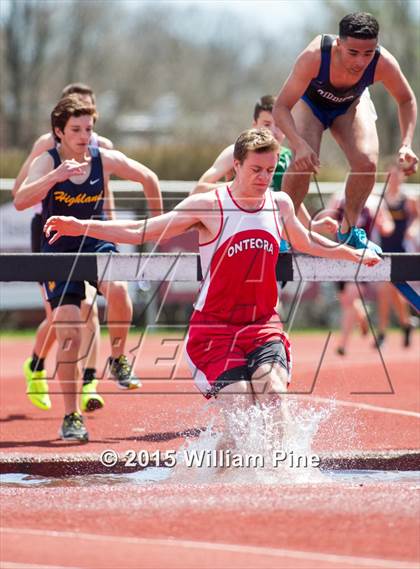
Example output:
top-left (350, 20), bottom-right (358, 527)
top-left (302, 34), bottom-right (381, 128)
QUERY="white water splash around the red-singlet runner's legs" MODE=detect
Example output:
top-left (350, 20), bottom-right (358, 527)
top-left (171, 396), bottom-right (335, 484)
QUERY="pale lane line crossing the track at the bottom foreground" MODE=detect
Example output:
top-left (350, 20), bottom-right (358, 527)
top-left (0, 528), bottom-right (419, 569)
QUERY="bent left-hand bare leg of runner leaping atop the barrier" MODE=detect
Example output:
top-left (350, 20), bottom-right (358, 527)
top-left (281, 100), bottom-right (324, 212)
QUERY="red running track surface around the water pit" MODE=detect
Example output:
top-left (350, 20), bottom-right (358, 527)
top-left (0, 335), bottom-right (420, 569)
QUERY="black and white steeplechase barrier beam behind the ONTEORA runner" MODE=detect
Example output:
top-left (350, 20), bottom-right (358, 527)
top-left (0, 253), bottom-right (420, 282)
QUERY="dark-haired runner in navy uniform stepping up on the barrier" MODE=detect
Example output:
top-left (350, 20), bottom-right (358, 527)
top-left (273, 12), bottom-right (418, 251)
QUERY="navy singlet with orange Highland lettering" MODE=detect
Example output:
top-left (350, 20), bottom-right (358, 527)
top-left (42, 146), bottom-right (104, 253)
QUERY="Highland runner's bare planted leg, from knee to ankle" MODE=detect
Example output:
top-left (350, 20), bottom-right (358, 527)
top-left (53, 304), bottom-right (83, 415)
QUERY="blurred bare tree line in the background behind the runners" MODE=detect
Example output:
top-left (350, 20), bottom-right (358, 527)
top-left (0, 0), bottom-right (420, 177)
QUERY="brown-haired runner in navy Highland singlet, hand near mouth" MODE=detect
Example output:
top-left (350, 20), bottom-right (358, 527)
top-left (14, 95), bottom-right (162, 442)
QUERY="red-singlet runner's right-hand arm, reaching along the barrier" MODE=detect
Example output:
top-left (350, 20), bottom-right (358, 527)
top-left (276, 192), bottom-right (380, 266)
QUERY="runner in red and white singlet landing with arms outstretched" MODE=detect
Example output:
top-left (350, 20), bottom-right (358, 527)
top-left (44, 129), bottom-right (380, 434)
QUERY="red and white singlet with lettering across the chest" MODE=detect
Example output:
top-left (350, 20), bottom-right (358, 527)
top-left (195, 186), bottom-right (281, 326)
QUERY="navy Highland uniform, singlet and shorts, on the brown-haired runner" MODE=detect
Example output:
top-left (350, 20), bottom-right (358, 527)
top-left (41, 147), bottom-right (117, 308)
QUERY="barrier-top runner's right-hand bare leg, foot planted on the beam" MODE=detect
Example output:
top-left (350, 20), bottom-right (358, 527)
top-left (331, 96), bottom-right (379, 233)
